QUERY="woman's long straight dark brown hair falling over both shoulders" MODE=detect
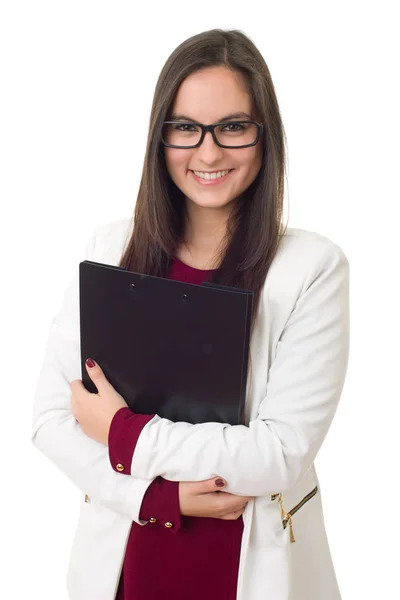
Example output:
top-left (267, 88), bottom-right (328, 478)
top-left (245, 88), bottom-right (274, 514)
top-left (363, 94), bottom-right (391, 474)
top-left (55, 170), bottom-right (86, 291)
top-left (119, 29), bottom-right (286, 325)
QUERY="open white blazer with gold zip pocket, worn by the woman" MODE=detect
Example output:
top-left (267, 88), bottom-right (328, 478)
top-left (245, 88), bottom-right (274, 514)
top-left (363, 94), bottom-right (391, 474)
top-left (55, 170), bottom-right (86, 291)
top-left (32, 219), bottom-right (349, 600)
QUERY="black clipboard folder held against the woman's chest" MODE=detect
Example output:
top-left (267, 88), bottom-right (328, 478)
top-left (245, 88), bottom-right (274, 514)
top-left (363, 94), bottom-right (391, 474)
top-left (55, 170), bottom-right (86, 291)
top-left (79, 260), bottom-right (253, 425)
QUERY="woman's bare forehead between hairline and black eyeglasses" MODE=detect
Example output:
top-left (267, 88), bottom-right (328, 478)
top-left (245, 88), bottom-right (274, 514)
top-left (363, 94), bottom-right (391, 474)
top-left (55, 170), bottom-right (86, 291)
top-left (172, 67), bottom-right (253, 123)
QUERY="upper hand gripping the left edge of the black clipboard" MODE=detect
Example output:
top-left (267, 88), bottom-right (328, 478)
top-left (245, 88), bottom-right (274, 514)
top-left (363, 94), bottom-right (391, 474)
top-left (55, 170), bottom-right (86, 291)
top-left (71, 359), bottom-right (128, 446)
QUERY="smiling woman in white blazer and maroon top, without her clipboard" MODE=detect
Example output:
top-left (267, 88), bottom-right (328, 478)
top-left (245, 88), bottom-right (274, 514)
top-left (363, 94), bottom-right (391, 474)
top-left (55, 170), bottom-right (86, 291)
top-left (32, 29), bottom-right (349, 600)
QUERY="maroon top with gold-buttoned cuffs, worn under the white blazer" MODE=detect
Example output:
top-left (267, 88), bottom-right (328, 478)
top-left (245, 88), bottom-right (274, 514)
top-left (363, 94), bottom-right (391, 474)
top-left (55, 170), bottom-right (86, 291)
top-left (108, 259), bottom-right (243, 600)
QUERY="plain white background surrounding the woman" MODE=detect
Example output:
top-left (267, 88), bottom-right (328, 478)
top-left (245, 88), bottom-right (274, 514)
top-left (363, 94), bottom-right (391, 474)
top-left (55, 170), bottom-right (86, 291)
top-left (0, 0), bottom-right (400, 600)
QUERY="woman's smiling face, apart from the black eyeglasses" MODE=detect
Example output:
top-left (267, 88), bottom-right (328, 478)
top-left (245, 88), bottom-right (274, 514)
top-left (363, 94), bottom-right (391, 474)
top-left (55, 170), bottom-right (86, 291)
top-left (164, 67), bottom-right (262, 210)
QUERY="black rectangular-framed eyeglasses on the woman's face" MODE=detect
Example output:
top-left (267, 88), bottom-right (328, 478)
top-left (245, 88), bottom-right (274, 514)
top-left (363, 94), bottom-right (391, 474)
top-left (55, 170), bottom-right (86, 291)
top-left (161, 121), bottom-right (264, 148)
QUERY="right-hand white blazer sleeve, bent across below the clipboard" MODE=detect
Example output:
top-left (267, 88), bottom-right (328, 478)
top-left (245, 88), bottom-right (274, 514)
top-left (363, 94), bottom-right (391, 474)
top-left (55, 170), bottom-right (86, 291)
top-left (131, 243), bottom-right (349, 496)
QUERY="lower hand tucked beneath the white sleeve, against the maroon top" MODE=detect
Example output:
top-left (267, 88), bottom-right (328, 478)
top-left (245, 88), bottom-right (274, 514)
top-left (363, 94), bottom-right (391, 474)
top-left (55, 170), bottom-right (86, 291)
top-left (179, 477), bottom-right (251, 521)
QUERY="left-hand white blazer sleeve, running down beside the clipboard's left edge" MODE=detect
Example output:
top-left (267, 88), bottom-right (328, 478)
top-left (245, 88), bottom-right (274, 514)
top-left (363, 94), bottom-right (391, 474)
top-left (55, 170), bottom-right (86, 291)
top-left (31, 225), bottom-right (154, 525)
